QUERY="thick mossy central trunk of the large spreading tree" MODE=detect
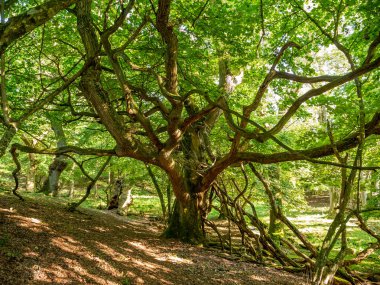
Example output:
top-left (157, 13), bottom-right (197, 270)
top-left (164, 55), bottom-right (236, 244)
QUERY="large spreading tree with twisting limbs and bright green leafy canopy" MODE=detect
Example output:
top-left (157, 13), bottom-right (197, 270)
top-left (0, 0), bottom-right (380, 280)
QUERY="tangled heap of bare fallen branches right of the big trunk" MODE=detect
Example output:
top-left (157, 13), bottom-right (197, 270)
top-left (205, 156), bottom-right (380, 281)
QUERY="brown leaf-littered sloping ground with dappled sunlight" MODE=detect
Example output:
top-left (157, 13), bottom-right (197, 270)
top-left (0, 193), bottom-right (308, 285)
